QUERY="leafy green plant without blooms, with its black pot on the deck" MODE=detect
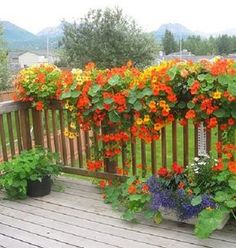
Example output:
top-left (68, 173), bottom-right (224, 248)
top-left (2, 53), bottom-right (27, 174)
top-left (0, 148), bottom-right (60, 199)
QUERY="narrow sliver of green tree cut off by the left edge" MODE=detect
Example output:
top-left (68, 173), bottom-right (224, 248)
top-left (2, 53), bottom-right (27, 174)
top-left (0, 26), bottom-right (9, 91)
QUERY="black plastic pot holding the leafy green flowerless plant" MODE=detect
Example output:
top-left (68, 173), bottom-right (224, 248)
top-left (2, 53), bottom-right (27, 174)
top-left (27, 176), bottom-right (52, 197)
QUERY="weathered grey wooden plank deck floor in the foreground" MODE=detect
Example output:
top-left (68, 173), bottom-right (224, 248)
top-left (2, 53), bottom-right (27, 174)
top-left (0, 177), bottom-right (236, 248)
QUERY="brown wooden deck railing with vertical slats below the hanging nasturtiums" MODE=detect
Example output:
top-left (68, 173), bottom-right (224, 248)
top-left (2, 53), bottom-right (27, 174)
top-left (0, 101), bottom-right (220, 178)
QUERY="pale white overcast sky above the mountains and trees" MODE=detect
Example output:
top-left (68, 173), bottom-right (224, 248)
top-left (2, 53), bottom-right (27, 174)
top-left (0, 0), bottom-right (236, 33)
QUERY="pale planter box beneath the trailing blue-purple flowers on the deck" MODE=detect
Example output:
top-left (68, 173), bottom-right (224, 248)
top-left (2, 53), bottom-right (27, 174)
top-left (159, 208), bottom-right (230, 230)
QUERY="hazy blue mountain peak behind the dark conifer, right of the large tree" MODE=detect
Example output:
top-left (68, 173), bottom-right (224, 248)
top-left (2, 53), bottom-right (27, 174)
top-left (153, 23), bottom-right (194, 40)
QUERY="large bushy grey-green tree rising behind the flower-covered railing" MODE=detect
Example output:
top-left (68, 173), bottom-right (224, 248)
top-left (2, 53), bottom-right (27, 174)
top-left (61, 8), bottom-right (158, 68)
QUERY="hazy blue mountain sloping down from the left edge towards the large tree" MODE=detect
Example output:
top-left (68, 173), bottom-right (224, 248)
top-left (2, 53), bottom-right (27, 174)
top-left (0, 21), bottom-right (60, 50)
